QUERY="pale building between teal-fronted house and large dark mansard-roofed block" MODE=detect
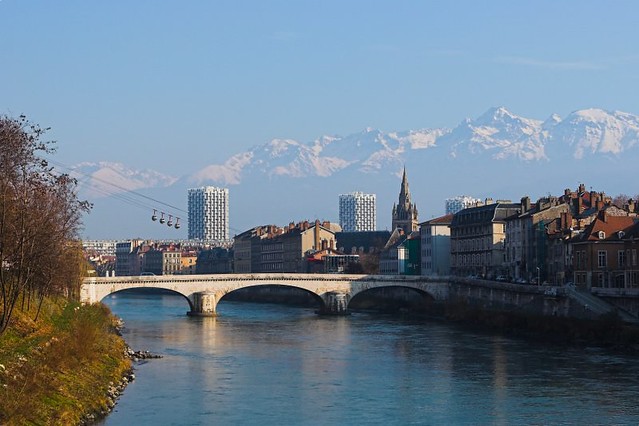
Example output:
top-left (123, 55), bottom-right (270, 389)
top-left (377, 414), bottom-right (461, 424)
top-left (419, 214), bottom-right (453, 275)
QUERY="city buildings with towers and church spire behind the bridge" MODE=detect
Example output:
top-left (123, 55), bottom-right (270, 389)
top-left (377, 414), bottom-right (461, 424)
top-left (83, 170), bottom-right (639, 289)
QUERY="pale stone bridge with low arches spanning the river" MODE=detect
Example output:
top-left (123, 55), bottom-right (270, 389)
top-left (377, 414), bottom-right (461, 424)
top-left (80, 274), bottom-right (449, 316)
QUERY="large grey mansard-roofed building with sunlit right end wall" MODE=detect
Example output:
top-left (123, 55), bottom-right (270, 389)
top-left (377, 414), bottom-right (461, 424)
top-left (450, 198), bottom-right (521, 278)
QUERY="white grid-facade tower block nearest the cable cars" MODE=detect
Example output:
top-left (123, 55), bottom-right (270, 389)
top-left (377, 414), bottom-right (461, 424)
top-left (188, 186), bottom-right (229, 241)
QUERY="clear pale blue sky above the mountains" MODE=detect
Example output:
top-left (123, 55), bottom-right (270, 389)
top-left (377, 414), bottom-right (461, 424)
top-left (0, 0), bottom-right (639, 176)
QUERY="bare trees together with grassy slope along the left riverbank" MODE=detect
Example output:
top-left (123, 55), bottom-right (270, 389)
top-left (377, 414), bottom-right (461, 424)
top-left (0, 116), bottom-right (130, 425)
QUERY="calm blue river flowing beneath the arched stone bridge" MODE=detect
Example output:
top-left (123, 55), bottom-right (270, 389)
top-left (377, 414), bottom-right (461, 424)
top-left (103, 293), bottom-right (639, 425)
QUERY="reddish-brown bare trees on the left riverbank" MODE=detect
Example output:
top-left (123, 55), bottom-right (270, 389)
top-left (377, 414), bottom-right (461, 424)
top-left (0, 116), bottom-right (88, 333)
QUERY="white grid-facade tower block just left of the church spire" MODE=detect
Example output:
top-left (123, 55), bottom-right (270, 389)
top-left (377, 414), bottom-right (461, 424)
top-left (339, 192), bottom-right (377, 232)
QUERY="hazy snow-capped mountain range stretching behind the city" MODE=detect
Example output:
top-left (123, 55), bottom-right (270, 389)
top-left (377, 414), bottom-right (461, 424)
top-left (74, 107), bottom-right (639, 238)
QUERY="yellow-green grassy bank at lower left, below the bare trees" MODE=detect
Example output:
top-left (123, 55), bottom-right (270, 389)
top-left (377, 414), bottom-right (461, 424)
top-left (0, 298), bottom-right (131, 425)
